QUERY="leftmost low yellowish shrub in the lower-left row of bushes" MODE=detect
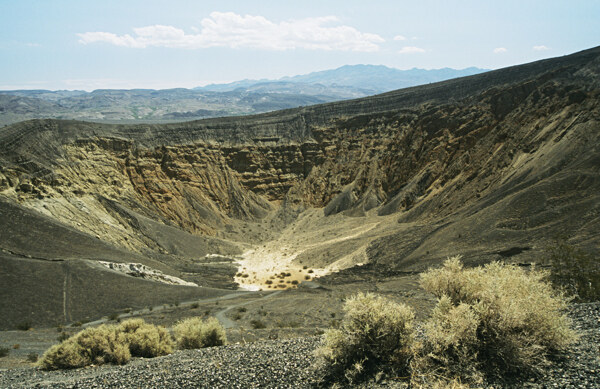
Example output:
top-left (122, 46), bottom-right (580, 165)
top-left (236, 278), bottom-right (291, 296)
top-left (39, 325), bottom-right (131, 370)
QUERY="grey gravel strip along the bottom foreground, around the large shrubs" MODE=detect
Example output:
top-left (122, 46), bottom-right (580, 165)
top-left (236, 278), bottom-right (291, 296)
top-left (0, 303), bottom-right (600, 389)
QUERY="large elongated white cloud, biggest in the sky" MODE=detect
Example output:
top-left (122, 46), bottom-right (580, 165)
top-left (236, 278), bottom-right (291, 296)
top-left (77, 12), bottom-right (384, 51)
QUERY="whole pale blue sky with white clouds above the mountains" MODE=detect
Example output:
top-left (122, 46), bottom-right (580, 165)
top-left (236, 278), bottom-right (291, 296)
top-left (0, 0), bottom-right (600, 90)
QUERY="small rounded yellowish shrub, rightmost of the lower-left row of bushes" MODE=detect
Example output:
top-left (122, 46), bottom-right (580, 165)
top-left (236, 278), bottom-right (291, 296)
top-left (173, 317), bottom-right (227, 349)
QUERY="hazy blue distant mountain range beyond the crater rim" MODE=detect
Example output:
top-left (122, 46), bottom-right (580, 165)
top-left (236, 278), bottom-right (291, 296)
top-left (0, 65), bottom-right (486, 125)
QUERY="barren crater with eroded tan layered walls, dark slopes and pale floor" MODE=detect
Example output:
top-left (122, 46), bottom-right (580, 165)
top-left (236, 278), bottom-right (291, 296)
top-left (0, 48), bottom-right (600, 328)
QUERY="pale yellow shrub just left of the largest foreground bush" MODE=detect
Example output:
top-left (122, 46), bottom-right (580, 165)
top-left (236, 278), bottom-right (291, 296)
top-left (316, 293), bottom-right (414, 384)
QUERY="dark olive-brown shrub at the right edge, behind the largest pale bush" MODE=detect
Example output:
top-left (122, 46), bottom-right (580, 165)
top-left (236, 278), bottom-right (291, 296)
top-left (546, 239), bottom-right (600, 301)
